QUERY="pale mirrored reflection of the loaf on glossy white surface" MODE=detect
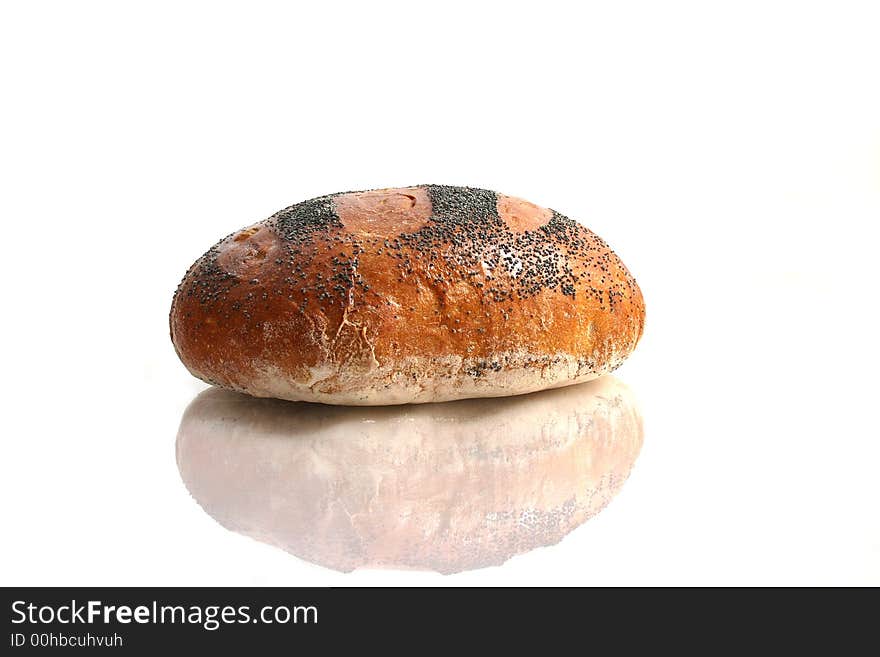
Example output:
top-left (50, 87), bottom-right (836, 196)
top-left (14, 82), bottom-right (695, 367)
top-left (177, 377), bottom-right (642, 573)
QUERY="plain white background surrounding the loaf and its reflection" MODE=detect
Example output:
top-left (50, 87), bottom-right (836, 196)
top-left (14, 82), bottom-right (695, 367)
top-left (0, 0), bottom-right (880, 585)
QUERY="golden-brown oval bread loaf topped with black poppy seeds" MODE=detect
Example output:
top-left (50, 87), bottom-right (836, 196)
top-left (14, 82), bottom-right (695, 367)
top-left (171, 185), bottom-right (645, 405)
